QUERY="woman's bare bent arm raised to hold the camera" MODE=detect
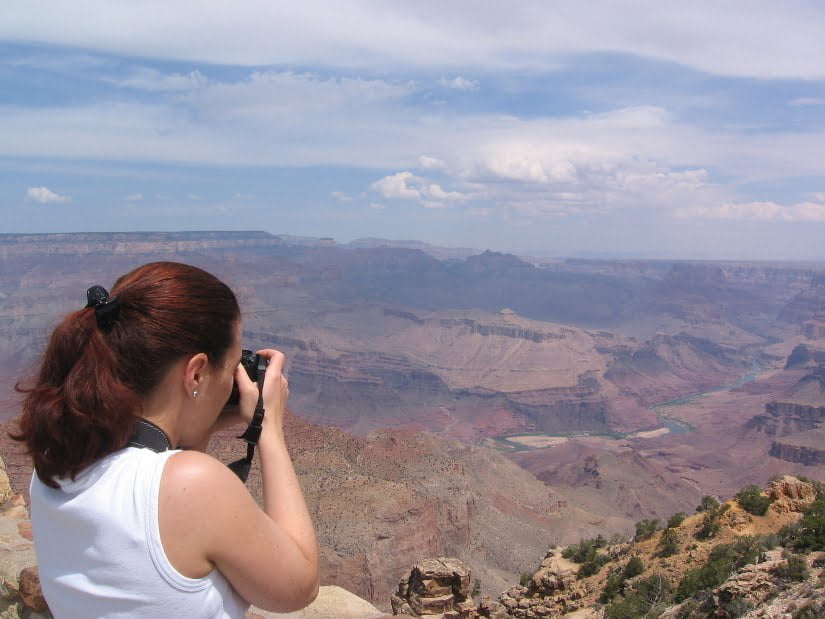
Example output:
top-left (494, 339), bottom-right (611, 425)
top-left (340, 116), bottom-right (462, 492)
top-left (160, 350), bottom-right (320, 612)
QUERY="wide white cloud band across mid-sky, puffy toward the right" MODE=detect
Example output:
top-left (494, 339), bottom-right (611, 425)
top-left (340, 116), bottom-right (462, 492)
top-left (0, 64), bottom-right (825, 228)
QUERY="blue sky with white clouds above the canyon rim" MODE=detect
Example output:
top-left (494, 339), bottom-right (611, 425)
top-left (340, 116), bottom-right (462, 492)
top-left (0, 0), bottom-right (825, 260)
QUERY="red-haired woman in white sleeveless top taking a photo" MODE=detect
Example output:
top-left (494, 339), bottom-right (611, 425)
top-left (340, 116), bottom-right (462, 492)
top-left (17, 262), bottom-right (319, 618)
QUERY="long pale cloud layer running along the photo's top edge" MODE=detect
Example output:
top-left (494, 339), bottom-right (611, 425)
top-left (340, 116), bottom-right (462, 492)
top-left (0, 0), bottom-right (825, 79)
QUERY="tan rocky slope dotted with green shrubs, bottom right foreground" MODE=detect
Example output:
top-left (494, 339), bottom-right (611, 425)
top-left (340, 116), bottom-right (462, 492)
top-left (393, 476), bottom-right (825, 619)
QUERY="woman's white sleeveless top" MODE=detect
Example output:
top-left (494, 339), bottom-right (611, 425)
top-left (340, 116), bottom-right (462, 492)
top-left (30, 447), bottom-right (249, 619)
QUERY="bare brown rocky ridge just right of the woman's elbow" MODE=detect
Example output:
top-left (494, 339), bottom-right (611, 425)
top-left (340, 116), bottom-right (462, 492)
top-left (211, 416), bottom-right (628, 608)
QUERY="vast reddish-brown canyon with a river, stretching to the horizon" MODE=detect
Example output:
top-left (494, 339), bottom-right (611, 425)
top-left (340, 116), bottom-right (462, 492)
top-left (0, 231), bottom-right (825, 609)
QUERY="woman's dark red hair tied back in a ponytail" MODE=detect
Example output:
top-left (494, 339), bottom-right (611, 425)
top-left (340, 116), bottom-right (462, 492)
top-left (12, 262), bottom-right (240, 488)
